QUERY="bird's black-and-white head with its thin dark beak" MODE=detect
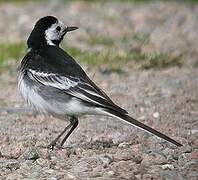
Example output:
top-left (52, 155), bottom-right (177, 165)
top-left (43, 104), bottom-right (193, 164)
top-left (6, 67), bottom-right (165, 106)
top-left (27, 16), bottom-right (78, 48)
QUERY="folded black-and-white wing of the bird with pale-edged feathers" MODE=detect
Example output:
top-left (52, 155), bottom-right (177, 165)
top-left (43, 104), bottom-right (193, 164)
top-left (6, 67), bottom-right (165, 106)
top-left (27, 69), bottom-right (127, 114)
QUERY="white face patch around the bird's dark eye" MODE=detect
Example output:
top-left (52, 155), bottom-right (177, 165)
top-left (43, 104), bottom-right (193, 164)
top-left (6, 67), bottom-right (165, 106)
top-left (45, 21), bottom-right (66, 46)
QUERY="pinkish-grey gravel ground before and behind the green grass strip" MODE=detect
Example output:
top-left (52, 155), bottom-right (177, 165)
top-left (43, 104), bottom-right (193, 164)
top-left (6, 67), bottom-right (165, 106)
top-left (0, 1), bottom-right (198, 180)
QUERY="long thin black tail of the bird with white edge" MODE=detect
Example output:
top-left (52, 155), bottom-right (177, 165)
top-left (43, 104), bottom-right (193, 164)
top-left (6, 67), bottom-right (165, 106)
top-left (105, 110), bottom-right (182, 146)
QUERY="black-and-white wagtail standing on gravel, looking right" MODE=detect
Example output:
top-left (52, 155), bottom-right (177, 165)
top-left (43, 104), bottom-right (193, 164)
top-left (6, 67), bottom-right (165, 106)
top-left (18, 16), bottom-right (182, 149)
